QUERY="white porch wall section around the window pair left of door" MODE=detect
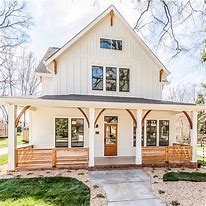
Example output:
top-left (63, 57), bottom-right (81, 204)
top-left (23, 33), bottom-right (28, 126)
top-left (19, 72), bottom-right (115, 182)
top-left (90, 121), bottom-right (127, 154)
top-left (31, 107), bottom-right (88, 148)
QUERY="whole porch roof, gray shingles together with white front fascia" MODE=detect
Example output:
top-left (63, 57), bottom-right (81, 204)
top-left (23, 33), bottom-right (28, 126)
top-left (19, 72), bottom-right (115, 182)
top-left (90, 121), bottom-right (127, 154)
top-left (0, 94), bottom-right (201, 111)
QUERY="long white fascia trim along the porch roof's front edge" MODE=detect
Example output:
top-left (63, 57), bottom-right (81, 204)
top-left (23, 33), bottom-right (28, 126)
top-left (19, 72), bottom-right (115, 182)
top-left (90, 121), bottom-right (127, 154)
top-left (0, 96), bottom-right (201, 112)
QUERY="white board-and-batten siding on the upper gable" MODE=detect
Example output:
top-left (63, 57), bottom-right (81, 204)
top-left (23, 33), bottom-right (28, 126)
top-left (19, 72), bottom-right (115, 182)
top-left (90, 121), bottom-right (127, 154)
top-left (42, 15), bottom-right (162, 99)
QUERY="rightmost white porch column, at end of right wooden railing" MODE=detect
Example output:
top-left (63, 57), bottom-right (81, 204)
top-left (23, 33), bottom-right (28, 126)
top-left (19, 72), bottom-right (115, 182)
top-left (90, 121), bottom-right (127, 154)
top-left (190, 111), bottom-right (197, 162)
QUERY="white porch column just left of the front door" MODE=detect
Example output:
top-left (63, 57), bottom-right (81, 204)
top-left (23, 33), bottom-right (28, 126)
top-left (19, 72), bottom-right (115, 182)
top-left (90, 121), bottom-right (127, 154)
top-left (89, 108), bottom-right (95, 167)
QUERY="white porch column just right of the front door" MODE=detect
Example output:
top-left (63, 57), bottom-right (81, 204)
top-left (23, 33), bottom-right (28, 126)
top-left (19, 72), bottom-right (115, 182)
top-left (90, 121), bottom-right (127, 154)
top-left (135, 109), bottom-right (142, 165)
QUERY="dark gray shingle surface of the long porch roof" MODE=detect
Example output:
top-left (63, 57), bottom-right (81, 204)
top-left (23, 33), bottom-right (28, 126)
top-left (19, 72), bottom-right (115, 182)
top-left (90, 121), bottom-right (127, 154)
top-left (40, 94), bottom-right (195, 105)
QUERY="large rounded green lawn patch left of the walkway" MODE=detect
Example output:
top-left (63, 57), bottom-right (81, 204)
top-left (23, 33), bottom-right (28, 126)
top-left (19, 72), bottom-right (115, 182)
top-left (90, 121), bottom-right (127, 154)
top-left (0, 177), bottom-right (90, 206)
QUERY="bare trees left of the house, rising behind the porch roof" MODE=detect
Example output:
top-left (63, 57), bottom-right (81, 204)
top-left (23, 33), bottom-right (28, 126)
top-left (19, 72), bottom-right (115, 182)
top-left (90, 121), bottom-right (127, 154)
top-left (0, 49), bottom-right (40, 121)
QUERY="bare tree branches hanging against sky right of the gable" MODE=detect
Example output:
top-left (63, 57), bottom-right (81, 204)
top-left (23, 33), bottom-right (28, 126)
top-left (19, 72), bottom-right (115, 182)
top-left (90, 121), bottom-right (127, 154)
top-left (135, 0), bottom-right (206, 57)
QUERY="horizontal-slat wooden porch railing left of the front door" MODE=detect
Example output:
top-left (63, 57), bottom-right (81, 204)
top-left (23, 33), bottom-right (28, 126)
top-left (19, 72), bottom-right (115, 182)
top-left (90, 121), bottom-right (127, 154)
top-left (16, 148), bottom-right (88, 169)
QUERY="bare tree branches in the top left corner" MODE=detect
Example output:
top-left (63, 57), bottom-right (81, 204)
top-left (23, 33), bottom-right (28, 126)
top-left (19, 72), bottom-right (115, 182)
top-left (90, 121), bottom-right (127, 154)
top-left (0, 0), bottom-right (32, 66)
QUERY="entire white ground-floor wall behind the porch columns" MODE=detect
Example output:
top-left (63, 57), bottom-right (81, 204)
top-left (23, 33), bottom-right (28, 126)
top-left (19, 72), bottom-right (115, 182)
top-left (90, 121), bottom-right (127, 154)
top-left (31, 107), bottom-right (176, 157)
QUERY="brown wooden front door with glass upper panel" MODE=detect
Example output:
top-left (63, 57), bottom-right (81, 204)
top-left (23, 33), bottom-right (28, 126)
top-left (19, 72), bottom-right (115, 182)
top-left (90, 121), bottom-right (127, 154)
top-left (104, 124), bottom-right (117, 156)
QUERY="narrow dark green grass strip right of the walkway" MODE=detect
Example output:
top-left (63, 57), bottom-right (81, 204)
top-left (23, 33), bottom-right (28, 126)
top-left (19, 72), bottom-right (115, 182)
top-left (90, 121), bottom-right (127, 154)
top-left (163, 172), bottom-right (206, 182)
